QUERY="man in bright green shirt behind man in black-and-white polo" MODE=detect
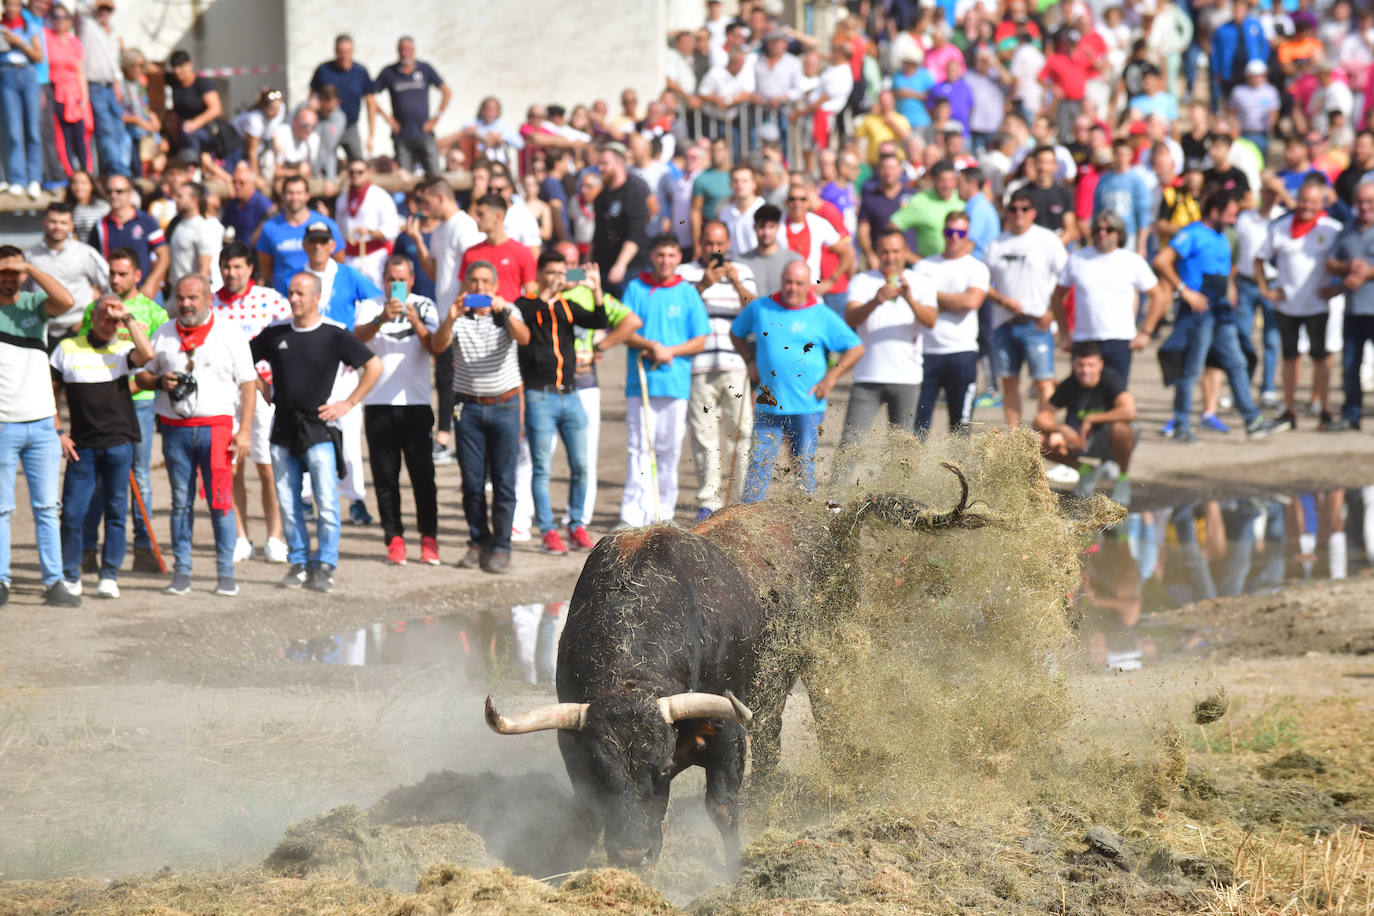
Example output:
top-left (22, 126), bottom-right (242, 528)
top-left (80, 249), bottom-right (168, 573)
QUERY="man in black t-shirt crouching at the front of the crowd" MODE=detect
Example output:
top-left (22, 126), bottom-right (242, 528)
top-left (1035, 341), bottom-right (1136, 505)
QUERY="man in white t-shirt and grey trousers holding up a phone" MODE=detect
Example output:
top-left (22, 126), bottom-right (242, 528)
top-left (840, 227), bottom-right (938, 449)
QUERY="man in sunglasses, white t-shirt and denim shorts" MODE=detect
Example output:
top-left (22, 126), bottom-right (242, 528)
top-left (987, 190), bottom-right (1069, 428)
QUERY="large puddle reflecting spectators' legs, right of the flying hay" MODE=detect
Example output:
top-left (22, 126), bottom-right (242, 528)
top-left (1077, 486), bottom-right (1374, 672)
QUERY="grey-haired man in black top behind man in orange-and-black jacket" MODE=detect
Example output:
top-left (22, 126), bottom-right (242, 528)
top-left (592, 143), bottom-right (649, 298)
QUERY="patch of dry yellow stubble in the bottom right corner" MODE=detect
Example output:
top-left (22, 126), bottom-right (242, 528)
top-left (1202, 827), bottom-right (1374, 916)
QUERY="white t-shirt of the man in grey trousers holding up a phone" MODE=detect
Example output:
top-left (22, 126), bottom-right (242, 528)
top-left (849, 268), bottom-right (936, 385)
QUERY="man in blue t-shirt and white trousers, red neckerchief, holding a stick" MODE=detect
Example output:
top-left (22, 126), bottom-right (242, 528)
top-left (620, 235), bottom-right (710, 527)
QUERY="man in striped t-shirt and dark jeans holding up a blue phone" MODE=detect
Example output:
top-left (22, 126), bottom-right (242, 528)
top-left (430, 261), bottom-right (529, 574)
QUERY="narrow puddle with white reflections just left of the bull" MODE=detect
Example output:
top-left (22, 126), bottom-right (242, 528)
top-left (286, 602), bottom-right (567, 684)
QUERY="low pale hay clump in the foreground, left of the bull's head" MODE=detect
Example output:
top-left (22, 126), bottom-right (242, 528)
top-left (262, 805), bottom-right (493, 890)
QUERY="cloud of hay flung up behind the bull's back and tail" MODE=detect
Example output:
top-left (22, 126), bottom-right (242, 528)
top-left (798, 430), bottom-right (1118, 803)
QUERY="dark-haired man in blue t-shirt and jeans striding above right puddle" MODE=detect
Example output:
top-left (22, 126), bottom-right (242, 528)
top-left (1145, 191), bottom-right (1274, 444)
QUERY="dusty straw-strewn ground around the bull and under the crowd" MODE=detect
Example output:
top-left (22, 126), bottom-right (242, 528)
top-left (0, 347), bottom-right (1374, 913)
